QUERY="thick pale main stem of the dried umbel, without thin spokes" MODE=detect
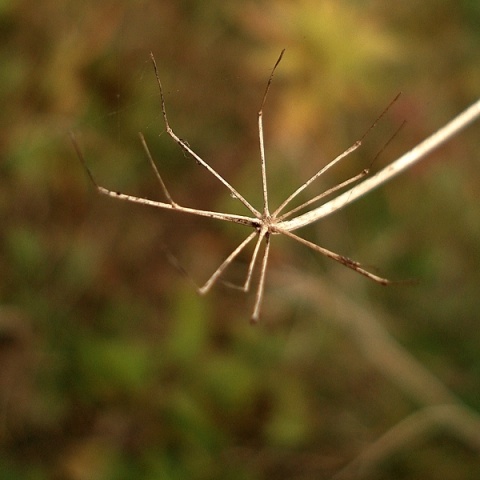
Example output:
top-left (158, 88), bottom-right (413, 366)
top-left (277, 99), bottom-right (480, 231)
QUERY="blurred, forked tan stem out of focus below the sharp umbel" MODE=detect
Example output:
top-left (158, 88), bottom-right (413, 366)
top-left (273, 270), bottom-right (480, 480)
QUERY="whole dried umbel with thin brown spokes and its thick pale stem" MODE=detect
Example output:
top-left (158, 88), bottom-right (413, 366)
top-left (70, 50), bottom-right (480, 323)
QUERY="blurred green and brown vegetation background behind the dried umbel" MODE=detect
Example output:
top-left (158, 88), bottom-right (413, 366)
top-left (0, 0), bottom-right (480, 480)
